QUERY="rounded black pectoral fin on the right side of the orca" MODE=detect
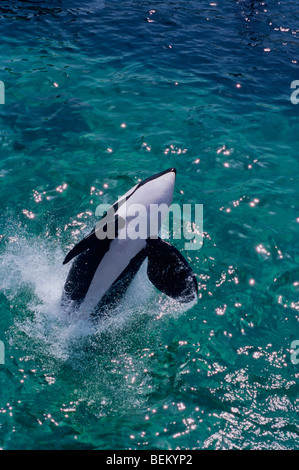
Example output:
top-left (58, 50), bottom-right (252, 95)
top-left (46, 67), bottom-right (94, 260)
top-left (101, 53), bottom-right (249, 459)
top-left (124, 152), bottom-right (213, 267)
top-left (147, 238), bottom-right (197, 302)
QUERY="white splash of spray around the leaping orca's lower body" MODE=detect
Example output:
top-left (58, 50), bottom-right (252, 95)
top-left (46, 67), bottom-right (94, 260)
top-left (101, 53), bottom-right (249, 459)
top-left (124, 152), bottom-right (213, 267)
top-left (0, 221), bottom-right (195, 367)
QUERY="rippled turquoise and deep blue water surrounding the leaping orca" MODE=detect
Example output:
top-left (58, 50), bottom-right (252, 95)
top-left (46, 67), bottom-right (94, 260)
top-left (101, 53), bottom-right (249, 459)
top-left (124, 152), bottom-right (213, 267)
top-left (0, 0), bottom-right (299, 449)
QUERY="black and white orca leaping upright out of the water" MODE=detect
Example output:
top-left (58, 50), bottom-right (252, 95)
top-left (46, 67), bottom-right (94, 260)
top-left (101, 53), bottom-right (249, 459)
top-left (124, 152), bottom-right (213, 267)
top-left (63, 168), bottom-right (197, 316)
